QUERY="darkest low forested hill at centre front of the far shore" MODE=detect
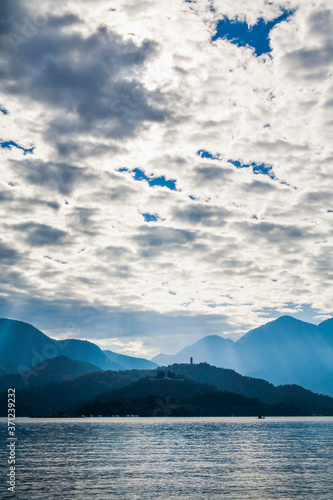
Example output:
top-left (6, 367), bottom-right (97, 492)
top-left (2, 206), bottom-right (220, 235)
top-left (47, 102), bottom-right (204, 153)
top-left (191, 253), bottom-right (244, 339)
top-left (75, 375), bottom-right (276, 417)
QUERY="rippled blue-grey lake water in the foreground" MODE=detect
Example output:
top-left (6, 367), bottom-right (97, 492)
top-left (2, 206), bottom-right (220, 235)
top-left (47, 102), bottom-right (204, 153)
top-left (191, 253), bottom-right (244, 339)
top-left (0, 417), bottom-right (333, 500)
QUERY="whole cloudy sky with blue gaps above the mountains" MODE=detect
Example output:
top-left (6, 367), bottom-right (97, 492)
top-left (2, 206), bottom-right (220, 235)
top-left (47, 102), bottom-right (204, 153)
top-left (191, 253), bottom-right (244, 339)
top-left (0, 0), bottom-right (333, 358)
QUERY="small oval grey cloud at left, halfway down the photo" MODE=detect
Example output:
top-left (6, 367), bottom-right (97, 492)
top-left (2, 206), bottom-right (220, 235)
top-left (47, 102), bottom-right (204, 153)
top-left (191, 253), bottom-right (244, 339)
top-left (15, 222), bottom-right (66, 247)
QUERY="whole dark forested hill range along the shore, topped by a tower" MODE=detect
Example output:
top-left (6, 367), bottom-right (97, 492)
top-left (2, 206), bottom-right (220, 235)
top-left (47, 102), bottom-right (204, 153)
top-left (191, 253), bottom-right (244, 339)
top-left (0, 363), bottom-right (333, 416)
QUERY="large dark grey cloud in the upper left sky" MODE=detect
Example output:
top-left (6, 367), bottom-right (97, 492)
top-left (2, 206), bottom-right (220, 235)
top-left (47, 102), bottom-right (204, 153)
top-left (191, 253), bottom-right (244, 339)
top-left (0, 1), bottom-right (167, 147)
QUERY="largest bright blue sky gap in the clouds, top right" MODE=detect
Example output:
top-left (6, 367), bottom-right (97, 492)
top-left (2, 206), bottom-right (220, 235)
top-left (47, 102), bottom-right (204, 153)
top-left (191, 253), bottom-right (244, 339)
top-left (212, 10), bottom-right (295, 56)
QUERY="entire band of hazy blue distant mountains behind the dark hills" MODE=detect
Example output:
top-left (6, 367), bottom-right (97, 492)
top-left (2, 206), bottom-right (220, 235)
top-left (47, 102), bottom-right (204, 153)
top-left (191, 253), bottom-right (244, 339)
top-left (0, 316), bottom-right (333, 396)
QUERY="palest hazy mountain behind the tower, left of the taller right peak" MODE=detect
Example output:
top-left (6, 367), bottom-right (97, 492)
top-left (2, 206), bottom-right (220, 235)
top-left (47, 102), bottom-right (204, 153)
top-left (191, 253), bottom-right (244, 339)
top-left (152, 335), bottom-right (237, 369)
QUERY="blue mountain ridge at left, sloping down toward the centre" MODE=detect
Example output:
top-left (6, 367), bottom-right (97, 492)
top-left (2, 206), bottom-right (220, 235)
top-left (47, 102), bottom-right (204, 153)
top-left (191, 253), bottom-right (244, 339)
top-left (0, 318), bottom-right (156, 375)
